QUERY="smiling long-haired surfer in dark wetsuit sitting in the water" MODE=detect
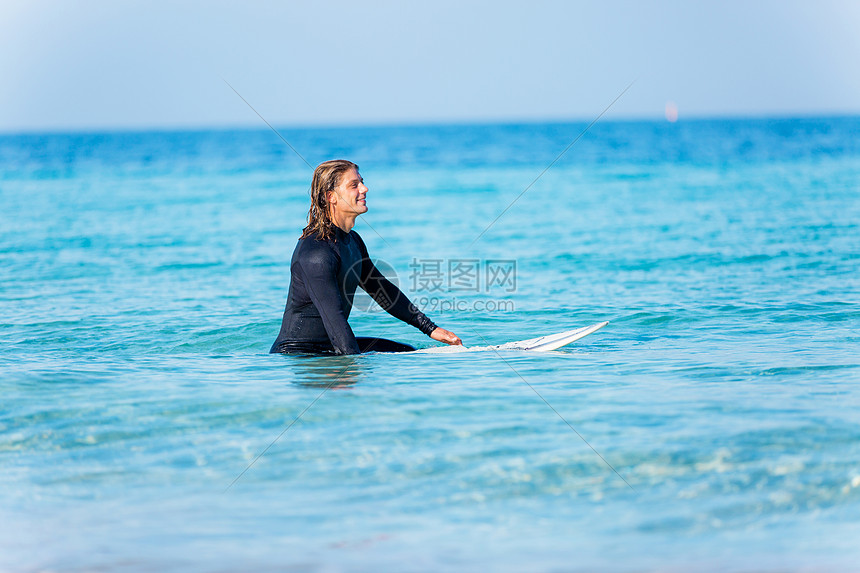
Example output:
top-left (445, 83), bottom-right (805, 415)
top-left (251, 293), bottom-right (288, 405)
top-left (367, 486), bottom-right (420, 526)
top-left (270, 159), bottom-right (462, 354)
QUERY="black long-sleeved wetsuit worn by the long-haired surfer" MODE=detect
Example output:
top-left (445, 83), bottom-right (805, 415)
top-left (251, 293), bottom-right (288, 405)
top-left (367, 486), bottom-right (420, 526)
top-left (271, 227), bottom-right (436, 354)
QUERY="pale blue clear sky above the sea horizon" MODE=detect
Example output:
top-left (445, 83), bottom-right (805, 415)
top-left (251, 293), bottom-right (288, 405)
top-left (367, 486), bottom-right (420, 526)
top-left (0, 0), bottom-right (860, 133)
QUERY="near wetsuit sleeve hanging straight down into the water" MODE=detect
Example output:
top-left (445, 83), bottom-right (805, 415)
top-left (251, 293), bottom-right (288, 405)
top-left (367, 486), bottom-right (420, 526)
top-left (295, 251), bottom-right (361, 354)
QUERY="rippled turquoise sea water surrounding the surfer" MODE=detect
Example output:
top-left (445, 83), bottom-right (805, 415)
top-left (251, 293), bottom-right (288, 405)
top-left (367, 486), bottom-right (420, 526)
top-left (0, 118), bottom-right (860, 572)
